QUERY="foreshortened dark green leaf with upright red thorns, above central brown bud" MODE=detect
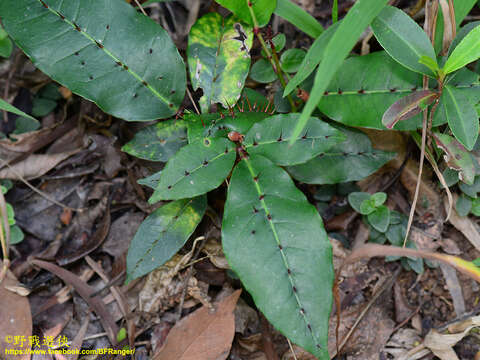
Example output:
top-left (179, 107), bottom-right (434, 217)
top-left (184, 112), bottom-right (270, 143)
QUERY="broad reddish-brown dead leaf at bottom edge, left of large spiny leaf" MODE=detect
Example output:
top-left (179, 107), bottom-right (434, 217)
top-left (153, 290), bottom-right (241, 360)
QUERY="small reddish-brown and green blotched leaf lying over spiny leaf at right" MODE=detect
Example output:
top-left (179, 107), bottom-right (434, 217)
top-left (382, 90), bottom-right (437, 129)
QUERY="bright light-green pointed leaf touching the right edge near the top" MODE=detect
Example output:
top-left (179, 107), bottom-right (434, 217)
top-left (443, 25), bottom-right (480, 74)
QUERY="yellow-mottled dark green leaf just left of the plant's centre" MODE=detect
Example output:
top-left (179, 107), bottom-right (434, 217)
top-left (122, 120), bottom-right (187, 162)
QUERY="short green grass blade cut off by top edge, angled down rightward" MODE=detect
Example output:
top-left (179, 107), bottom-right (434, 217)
top-left (274, 0), bottom-right (323, 38)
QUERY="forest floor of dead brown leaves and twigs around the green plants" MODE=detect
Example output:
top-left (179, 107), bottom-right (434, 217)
top-left (0, 0), bottom-right (480, 360)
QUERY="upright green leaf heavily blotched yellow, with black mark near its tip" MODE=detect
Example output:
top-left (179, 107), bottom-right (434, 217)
top-left (187, 13), bottom-right (253, 112)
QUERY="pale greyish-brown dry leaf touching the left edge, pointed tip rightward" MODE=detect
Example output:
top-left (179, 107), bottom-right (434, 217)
top-left (0, 149), bottom-right (80, 180)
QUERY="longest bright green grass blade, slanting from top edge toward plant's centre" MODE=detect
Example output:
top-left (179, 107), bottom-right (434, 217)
top-left (290, 0), bottom-right (388, 145)
